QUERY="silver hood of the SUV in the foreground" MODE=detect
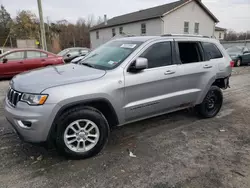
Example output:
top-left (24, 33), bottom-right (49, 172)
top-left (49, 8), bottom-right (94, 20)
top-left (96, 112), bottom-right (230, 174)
top-left (10, 64), bottom-right (106, 93)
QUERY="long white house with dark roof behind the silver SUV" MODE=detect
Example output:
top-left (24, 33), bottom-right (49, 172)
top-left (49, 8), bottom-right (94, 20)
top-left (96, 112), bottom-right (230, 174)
top-left (90, 0), bottom-right (219, 48)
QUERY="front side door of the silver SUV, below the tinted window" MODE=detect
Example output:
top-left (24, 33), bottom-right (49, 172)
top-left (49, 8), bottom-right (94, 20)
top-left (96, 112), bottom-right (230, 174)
top-left (124, 40), bottom-right (180, 121)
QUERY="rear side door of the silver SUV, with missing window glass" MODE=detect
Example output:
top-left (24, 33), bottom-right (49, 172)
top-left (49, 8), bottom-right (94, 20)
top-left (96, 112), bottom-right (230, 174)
top-left (174, 39), bottom-right (217, 107)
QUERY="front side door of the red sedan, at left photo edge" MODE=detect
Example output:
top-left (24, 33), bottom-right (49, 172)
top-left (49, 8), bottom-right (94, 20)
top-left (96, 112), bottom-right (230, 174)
top-left (0, 51), bottom-right (25, 77)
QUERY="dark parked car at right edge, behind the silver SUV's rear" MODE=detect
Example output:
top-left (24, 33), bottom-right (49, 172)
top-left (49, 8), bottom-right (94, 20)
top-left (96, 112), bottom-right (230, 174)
top-left (226, 46), bottom-right (250, 67)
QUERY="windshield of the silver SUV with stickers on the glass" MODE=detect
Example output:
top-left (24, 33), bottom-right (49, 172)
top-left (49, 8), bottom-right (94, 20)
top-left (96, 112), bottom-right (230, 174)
top-left (79, 41), bottom-right (143, 70)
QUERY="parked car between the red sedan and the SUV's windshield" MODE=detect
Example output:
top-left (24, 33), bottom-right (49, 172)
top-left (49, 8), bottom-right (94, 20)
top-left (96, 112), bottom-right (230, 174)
top-left (57, 47), bottom-right (90, 63)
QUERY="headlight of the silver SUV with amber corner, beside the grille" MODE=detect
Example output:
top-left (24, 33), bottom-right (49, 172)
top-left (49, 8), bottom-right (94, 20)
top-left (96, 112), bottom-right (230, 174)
top-left (21, 93), bottom-right (48, 105)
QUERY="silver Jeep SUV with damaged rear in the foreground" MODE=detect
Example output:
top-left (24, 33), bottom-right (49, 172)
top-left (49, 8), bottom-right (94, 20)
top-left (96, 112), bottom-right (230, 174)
top-left (4, 35), bottom-right (233, 158)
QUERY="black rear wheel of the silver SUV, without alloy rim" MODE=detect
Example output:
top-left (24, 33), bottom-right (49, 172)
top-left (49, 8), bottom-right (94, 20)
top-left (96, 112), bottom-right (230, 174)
top-left (196, 86), bottom-right (223, 118)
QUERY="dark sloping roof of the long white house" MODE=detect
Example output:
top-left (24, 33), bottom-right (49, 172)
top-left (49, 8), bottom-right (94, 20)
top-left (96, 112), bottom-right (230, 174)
top-left (90, 0), bottom-right (219, 31)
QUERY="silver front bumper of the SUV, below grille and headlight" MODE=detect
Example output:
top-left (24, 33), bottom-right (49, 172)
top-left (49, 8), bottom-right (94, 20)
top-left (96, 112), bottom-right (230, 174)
top-left (4, 99), bottom-right (56, 143)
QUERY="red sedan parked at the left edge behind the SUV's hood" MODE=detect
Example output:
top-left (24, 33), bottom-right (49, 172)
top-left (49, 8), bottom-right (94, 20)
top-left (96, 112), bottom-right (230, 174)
top-left (0, 49), bottom-right (64, 78)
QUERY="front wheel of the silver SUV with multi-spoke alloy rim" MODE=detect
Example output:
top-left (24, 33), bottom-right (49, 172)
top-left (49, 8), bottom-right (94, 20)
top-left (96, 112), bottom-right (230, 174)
top-left (56, 107), bottom-right (110, 159)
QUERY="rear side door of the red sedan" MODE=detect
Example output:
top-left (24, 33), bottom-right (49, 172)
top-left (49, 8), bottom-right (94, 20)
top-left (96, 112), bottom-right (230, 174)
top-left (24, 50), bottom-right (48, 70)
